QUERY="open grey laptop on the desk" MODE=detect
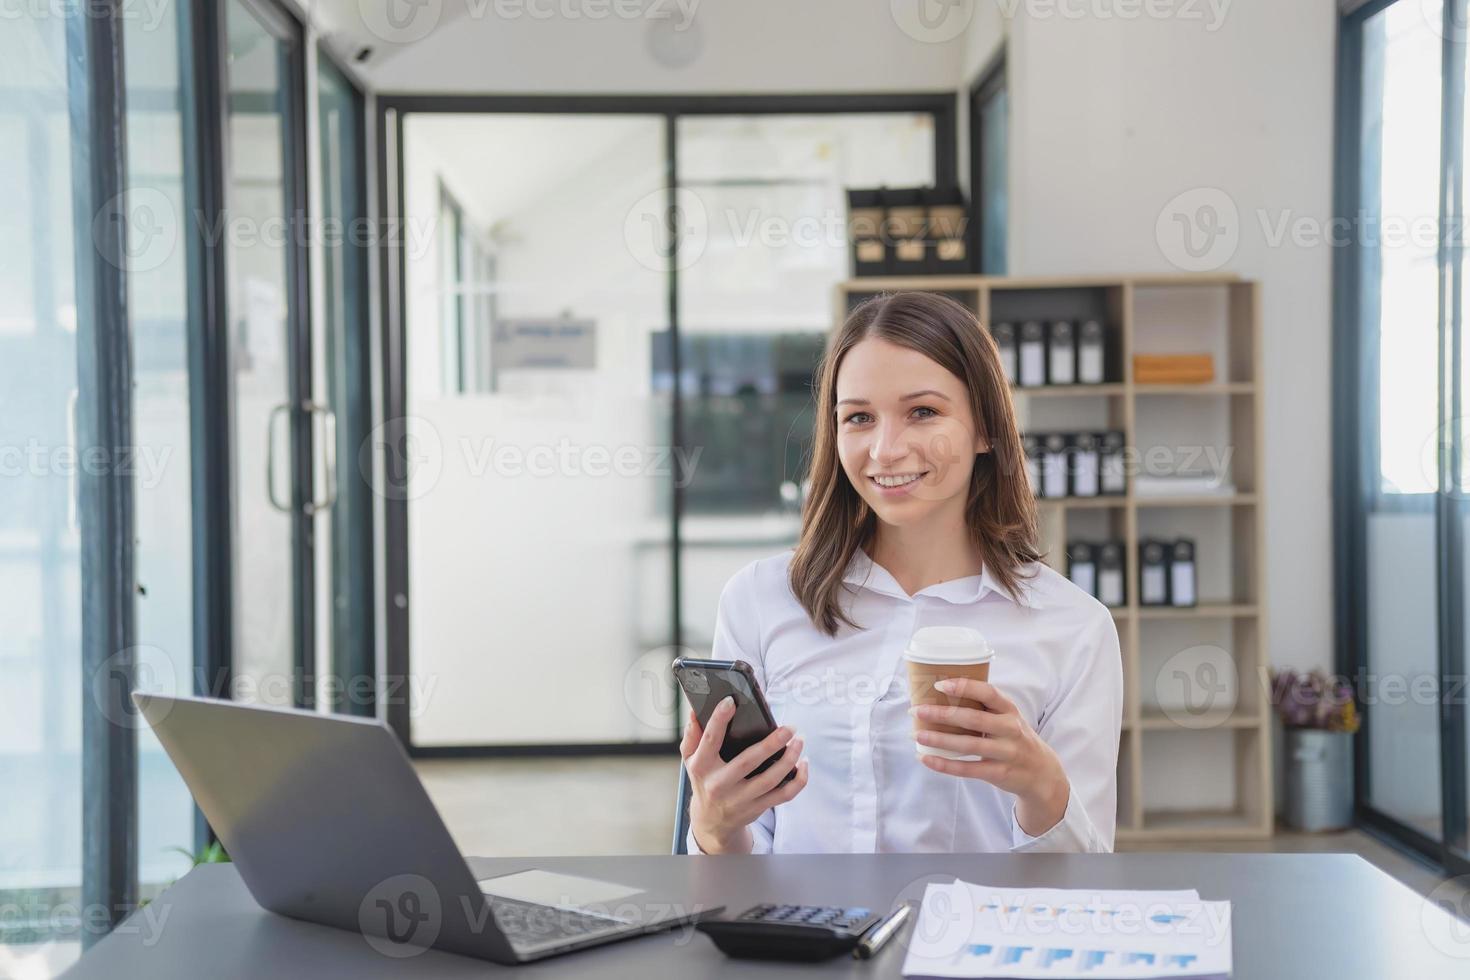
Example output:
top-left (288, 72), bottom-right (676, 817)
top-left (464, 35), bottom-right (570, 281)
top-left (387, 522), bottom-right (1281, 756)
top-left (132, 693), bottom-right (723, 964)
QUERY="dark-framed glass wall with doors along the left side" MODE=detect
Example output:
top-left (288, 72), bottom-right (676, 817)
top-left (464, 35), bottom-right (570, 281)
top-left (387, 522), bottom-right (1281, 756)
top-left (0, 0), bottom-right (373, 976)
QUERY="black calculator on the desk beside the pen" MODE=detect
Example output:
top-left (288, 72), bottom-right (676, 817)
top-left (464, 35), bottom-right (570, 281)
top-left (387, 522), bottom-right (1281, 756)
top-left (695, 905), bottom-right (879, 959)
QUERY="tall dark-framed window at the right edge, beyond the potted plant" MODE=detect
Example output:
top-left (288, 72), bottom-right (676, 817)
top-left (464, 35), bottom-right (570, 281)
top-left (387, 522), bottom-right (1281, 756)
top-left (1335, 0), bottom-right (1470, 870)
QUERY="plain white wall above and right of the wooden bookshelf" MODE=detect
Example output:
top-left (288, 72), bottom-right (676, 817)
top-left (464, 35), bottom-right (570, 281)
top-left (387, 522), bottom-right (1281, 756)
top-left (987, 0), bottom-right (1336, 669)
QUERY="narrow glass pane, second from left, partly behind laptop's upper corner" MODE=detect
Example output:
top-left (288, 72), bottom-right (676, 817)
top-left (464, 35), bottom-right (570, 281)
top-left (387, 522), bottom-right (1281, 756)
top-left (122, 4), bottom-right (194, 893)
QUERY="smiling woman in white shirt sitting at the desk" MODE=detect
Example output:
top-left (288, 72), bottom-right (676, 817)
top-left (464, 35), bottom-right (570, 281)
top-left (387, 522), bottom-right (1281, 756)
top-left (681, 292), bottom-right (1123, 854)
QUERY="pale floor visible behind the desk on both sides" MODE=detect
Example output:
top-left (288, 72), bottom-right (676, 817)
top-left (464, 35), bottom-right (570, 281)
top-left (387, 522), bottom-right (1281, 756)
top-left (417, 757), bottom-right (1470, 909)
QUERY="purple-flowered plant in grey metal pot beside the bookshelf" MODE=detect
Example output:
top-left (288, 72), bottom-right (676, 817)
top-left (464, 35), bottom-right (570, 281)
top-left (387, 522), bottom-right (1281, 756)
top-left (1272, 670), bottom-right (1360, 830)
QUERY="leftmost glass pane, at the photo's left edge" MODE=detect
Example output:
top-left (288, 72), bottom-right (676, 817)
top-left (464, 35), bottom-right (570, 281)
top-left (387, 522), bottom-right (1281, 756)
top-left (0, 9), bottom-right (82, 973)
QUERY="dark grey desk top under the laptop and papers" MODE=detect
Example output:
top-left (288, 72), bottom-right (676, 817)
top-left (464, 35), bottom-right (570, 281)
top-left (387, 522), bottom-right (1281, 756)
top-left (66, 854), bottom-right (1470, 980)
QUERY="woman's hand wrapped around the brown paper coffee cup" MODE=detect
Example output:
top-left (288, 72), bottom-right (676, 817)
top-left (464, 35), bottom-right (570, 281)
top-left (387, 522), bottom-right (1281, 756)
top-left (913, 677), bottom-right (1072, 837)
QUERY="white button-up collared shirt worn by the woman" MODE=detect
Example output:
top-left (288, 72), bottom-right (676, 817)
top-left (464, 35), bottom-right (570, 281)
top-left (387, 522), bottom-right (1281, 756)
top-left (688, 550), bottom-right (1123, 854)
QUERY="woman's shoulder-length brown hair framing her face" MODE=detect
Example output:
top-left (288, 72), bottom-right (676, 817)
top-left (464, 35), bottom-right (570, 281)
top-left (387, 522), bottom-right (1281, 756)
top-left (789, 292), bottom-right (1041, 636)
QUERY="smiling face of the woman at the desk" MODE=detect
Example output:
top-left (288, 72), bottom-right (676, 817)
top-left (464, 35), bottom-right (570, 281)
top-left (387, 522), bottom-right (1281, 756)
top-left (836, 336), bottom-right (989, 526)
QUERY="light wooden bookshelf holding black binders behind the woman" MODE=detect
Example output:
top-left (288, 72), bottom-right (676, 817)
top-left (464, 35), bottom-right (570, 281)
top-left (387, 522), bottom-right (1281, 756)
top-left (836, 275), bottom-right (1274, 843)
